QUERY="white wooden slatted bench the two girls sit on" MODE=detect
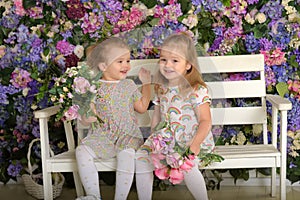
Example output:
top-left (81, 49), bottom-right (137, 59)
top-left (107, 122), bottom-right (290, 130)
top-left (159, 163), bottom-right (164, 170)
top-left (34, 55), bottom-right (292, 200)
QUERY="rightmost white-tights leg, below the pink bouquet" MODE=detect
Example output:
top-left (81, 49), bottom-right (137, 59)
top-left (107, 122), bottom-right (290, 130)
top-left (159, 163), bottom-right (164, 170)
top-left (184, 161), bottom-right (208, 200)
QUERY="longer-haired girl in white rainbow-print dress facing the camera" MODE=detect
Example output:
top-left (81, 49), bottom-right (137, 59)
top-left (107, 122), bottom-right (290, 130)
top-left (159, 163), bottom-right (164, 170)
top-left (143, 33), bottom-right (214, 200)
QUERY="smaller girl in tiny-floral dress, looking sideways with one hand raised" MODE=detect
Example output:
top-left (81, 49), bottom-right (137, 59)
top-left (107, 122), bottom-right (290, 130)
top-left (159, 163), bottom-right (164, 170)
top-left (76, 37), bottom-right (152, 200)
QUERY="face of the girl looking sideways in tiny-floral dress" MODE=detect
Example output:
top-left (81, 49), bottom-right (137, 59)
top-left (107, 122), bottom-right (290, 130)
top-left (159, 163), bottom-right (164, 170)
top-left (99, 48), bottom-right (131, 81)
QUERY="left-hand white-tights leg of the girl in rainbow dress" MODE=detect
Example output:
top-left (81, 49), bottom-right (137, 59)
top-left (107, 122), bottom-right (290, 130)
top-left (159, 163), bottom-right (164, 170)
top-left (135, 150), bottom-right (153, 200)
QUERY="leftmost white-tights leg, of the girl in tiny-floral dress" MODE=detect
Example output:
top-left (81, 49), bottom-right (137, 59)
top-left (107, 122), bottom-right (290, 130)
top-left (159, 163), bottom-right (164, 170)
top-left (76, 145), bottom-right (101, 199)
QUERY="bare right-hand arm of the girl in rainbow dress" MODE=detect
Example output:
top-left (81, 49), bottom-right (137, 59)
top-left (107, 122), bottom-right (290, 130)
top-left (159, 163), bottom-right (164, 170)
top-left (190, 102), bottom-right (211, 155)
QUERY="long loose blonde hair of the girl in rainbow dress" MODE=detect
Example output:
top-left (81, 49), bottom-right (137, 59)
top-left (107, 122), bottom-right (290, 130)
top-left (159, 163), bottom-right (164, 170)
top-left (155, 33), bottom-right (206, 93)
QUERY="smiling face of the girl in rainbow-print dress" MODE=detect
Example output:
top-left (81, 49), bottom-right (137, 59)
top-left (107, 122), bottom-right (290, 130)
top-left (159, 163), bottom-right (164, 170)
top-left (159, 50), bottom-right (191, 86)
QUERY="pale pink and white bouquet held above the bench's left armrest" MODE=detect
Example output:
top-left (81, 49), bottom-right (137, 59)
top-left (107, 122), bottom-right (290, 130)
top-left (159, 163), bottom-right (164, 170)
top-left (49, 64), bottom-right (103, 124)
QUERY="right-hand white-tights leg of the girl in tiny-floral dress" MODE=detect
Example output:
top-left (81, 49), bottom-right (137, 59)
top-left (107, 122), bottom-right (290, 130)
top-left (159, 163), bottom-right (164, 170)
top-left (115, 149), bottom-right (135, 200)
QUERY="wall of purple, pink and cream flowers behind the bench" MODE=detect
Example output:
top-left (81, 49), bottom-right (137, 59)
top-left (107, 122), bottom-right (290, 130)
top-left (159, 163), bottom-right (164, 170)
top-left (0, 0), bottom-right (300, 183)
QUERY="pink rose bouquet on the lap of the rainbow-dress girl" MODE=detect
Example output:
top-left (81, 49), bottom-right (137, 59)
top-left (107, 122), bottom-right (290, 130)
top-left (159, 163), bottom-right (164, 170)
top-left (150, 115), bottom-right (223, 184)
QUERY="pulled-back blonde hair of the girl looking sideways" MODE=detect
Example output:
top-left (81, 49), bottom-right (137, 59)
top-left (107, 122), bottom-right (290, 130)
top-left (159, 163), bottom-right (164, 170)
top-left (86, 37), bottom-right (130, 72)
